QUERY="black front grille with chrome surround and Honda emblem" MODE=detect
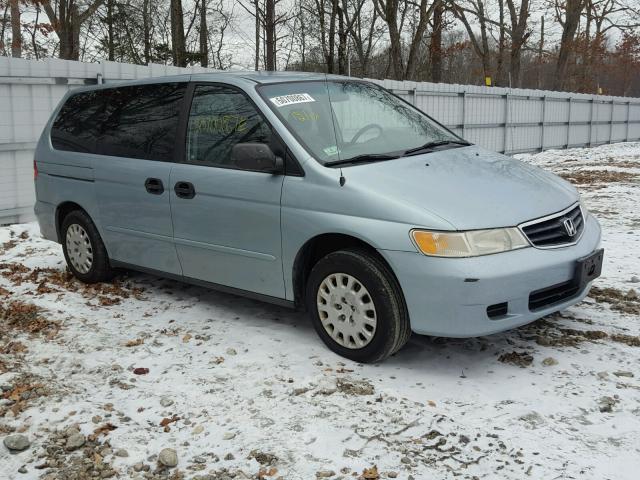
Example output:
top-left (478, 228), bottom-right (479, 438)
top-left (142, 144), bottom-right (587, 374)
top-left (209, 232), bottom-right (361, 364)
top-left (522, 205), bottom-right (584, 247)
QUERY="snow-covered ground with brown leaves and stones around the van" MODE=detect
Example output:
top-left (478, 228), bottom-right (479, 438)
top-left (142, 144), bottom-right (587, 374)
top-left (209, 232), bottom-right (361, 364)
top-left (0, 143), bottom-right (640, 480)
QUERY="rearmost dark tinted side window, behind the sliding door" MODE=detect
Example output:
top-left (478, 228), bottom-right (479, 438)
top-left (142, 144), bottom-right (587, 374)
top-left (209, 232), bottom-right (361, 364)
top-left (51, 91), bottom-right (104, 152)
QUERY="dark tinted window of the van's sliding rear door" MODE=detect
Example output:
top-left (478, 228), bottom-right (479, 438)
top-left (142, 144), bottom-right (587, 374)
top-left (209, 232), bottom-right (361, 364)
top-left (96, 83), bottom-right (186, 161)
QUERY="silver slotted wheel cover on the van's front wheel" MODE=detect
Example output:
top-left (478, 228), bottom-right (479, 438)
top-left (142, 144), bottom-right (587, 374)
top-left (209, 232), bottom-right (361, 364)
top-left (317, 273), bottom-right (378, 350)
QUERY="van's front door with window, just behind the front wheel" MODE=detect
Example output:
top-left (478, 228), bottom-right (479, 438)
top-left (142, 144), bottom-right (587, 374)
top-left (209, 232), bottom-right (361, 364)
top-left (171, 84), bottom-right (284, 298)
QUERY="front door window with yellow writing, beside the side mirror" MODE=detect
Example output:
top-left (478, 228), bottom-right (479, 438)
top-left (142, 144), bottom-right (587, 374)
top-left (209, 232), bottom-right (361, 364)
top-left (187, 85), bottom-right (271, 167)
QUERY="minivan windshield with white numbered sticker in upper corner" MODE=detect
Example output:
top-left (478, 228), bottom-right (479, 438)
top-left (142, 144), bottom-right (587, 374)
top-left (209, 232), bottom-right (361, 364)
top-left (259, 80), bottom-right (465, 165)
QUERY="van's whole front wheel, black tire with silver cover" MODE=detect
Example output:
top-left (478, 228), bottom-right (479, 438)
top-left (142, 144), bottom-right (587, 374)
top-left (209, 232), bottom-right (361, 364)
top-left (306, 249), bottom-right (411, 363)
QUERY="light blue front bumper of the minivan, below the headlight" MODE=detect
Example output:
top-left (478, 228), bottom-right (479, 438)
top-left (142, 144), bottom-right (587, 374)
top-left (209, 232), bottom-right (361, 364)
top-left (380, 215), bottom-right (601, 337)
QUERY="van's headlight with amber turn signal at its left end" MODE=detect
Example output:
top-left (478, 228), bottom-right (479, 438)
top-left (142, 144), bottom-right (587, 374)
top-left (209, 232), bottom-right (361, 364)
top-left (411, 228), bottom-right (529, 257)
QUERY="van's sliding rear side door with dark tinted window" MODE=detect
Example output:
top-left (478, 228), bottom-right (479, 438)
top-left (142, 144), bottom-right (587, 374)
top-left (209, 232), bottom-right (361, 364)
top-left (93, 83), bottom-right (187, 275)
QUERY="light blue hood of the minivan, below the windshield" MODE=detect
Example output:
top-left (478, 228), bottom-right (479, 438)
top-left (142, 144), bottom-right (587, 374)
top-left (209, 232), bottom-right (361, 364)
top-left (343, 145), bottom-right (578, 230)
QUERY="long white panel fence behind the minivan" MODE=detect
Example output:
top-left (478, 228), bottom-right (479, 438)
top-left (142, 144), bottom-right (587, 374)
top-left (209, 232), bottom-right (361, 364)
top-left (0, 57), bottom-right (640, 224)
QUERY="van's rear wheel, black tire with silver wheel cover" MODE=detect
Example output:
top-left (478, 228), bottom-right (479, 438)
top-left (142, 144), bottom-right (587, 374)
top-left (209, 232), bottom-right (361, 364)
top-left (60, 210), bottom-right (113, 283)
